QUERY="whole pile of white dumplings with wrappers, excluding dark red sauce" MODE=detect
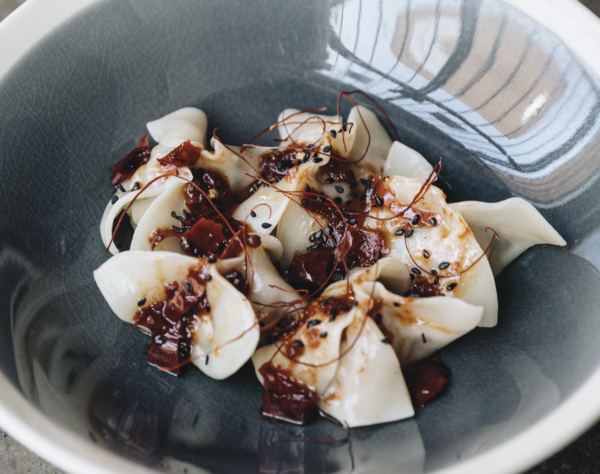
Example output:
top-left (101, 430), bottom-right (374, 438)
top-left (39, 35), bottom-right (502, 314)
top-left (94, 106), bottom-right (565, 427)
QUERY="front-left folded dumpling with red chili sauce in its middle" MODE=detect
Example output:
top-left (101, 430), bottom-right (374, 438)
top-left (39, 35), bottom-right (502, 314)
top-left (94, 251), bottom-right (260, 379)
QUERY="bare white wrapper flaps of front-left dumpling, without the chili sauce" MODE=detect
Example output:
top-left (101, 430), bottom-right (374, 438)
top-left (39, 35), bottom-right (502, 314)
top-left (94, 251), bottom-right (260, 380)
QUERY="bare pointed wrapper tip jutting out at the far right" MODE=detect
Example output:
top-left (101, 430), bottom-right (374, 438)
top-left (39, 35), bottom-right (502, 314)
top-left (450, 198), bottom-right (567, 276)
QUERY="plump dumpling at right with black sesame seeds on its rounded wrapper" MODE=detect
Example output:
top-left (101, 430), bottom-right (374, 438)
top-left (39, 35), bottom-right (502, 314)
top-left (380, 176), bottom-right (498, 327)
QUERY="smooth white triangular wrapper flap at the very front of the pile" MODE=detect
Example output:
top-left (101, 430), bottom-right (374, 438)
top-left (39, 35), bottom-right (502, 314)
top-left (319, 316), bottom-right (415, 428)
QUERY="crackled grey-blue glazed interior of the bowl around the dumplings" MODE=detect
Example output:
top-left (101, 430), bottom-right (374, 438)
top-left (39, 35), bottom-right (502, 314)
top-left (0, 0), bottom-right (600, 474)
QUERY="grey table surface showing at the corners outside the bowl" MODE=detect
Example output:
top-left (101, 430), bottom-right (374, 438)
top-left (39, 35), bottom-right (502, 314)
top-left (0, 0), bottom-right (600, 474)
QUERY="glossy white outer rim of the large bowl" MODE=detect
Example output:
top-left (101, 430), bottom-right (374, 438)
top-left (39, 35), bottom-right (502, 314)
top-left (0, 0), bottom-right (600, 474)
